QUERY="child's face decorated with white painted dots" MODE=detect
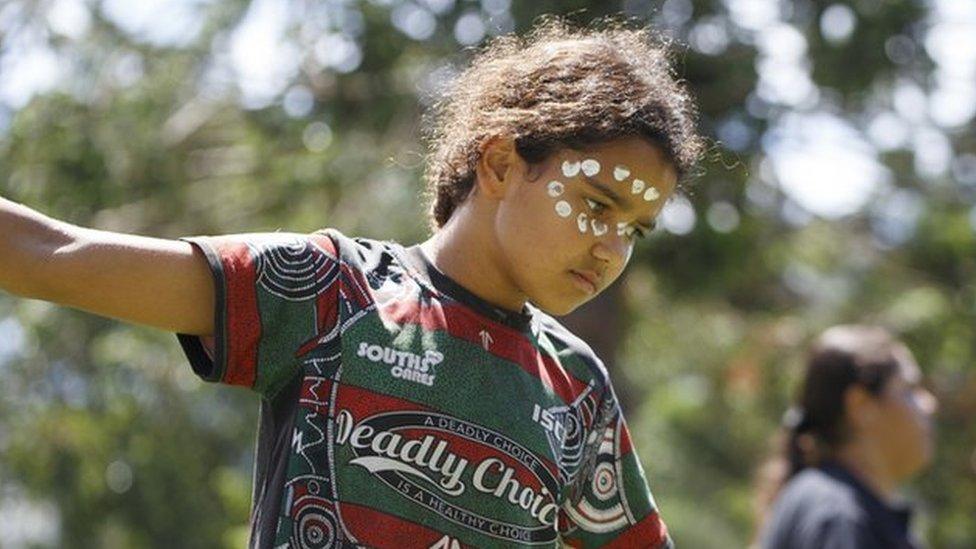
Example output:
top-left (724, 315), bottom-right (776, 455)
top-left (496, 137), bottom-right (677, 314)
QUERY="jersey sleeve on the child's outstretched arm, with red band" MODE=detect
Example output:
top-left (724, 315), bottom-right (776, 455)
top-left (178, 233), bottom-right (341, 396)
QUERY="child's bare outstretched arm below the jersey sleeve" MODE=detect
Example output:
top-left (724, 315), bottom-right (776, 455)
top-left (0, 198), bottom-right (215, 335)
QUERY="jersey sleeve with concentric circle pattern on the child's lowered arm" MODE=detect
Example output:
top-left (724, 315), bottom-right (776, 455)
top-left (559, 387), bottom-right (673, 548)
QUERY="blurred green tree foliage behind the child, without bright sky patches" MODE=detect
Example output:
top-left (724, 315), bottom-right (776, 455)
top-left (0, 0), bottom-right (976, 548)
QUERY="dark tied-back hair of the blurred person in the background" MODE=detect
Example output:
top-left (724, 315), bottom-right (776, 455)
top-left (758, 324), bottom-right (907, 532)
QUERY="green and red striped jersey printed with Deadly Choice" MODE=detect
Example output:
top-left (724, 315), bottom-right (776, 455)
top-left (179, 230), bottom-right (671, 549)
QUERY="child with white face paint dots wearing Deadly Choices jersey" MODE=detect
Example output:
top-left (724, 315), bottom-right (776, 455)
top-left (0, 22), bottom-right (701, 548)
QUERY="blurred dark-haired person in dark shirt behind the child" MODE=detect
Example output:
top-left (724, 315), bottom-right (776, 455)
top-left (760, 325), bottom-right (936, 549)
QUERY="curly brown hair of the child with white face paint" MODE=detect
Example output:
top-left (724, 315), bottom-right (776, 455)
top-left (425, 18), bottom-right (703, 229)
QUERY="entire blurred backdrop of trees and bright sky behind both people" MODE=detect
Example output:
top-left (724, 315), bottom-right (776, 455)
top-left (0, 0), bottom-right (976, 548)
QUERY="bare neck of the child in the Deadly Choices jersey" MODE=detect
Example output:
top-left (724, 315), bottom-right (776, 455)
top-left (420, 201), bottom-right (526, 311)
